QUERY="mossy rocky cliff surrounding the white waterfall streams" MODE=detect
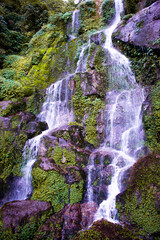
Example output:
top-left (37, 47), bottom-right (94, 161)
top-left (0, 0), bottom-right (160, 240)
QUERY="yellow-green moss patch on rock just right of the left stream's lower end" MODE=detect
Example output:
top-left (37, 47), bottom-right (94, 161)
top-left (31, 167), bottom-right (69, 212)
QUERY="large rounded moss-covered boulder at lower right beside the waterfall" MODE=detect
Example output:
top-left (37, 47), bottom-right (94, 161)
top-left (118, 154), bottom-right (160, 235)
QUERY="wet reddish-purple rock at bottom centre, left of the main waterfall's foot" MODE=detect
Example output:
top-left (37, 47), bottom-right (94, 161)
top-left (38, 202), bottom-right (98, 240)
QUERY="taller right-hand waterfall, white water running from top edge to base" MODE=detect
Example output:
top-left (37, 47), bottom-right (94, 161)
top-left (87, 0), bottom-right (145, 223)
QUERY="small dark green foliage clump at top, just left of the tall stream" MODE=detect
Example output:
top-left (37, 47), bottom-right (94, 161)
top-left (102, 0), bottom-right (115, 24)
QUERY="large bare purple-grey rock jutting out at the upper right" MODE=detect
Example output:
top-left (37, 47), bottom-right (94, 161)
top-left (115, 1), bottom-right (160, 49)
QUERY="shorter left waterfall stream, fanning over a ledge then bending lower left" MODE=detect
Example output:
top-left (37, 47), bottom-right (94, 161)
top-left (1, 75), bottom-right (74, 204)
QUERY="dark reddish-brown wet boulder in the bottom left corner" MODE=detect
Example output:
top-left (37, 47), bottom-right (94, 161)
top-left (1, 200), bottom-right (50, 231)
